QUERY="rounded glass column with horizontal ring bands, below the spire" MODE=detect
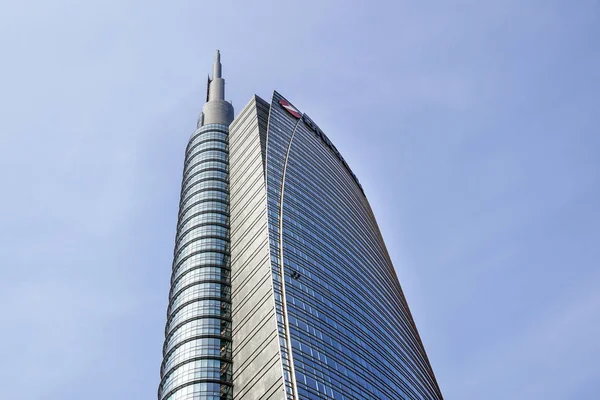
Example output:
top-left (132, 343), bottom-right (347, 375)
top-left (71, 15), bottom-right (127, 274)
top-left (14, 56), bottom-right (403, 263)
top-left (158, 124), bottom-right (232, 400)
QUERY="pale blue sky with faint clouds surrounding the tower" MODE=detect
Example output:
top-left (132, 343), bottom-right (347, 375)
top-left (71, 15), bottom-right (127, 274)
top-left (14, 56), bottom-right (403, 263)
top-left (0, 0), bottom-right (600, 400)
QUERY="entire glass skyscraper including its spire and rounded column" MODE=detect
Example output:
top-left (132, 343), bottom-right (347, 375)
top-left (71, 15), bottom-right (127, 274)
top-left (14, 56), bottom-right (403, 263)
top-left (159, 53), bottom-right (442, 400)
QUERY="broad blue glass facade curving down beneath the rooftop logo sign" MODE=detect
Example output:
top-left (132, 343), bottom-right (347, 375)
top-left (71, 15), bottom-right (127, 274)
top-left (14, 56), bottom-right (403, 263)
top-left (266, 92), bottom-right (442, 400)
